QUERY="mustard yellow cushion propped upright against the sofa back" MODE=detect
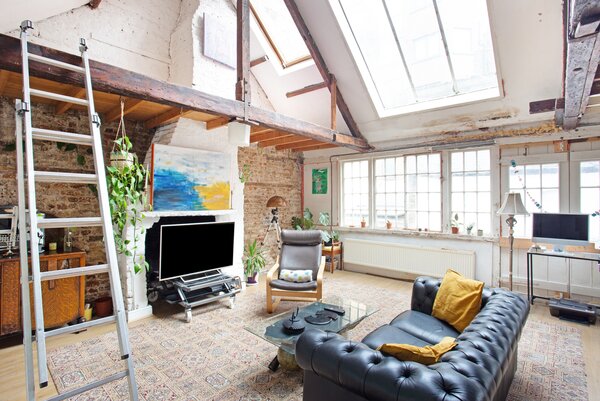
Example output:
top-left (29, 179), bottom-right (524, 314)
top-left (431, 269), bottom-right (483, 332)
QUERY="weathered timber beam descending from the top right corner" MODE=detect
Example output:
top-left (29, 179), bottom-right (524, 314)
top-left (562, 0), bottom-right (600, 130)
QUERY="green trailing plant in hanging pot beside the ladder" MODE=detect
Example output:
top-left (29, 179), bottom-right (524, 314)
top-left (106, 136), bottom-right (150, 273)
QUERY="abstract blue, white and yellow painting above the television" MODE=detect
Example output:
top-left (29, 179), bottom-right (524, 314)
top-left (152, 144), bottom-right (231, 211)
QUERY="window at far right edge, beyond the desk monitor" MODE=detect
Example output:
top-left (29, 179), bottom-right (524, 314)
top-left (579, 161), bottom-right (600, 242)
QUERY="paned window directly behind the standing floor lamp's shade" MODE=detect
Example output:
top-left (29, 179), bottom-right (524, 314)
top-left (505, 163), bottom-right (560, 238)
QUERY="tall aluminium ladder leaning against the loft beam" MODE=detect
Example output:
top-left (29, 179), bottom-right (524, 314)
top-left (16, 21), bottom-right (138, 401)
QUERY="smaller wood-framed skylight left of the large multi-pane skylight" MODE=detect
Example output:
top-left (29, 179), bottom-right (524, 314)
top-left (250, 0), bottom-right (311, 68)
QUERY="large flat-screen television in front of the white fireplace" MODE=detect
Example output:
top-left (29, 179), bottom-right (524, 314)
top-left (158, 222), bottom-right (235, 281)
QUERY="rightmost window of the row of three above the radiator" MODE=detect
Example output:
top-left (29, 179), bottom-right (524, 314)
top-left (450, 149), bottom-right (492, 235)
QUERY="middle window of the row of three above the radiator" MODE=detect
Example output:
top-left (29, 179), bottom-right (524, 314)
top-left (375, 153), bottom-right (442, 231)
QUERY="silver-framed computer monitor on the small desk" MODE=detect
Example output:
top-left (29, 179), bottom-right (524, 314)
top-left (532, 213), bottom-right (589, 251)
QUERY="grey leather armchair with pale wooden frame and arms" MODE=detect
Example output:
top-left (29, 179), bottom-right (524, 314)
top-left (266, 230), bottom-right (325, 313)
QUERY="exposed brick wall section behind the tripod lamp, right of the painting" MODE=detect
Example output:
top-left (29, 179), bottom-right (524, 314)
top-left (238, 145), bottom-right (302, 265)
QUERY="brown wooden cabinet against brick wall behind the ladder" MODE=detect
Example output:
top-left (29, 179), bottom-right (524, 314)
top-left (0, 250), bottom-right (85, 335)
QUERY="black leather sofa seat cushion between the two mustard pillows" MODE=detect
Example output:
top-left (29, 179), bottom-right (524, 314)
top-left (390, 310), bottom-right (459, 344)
